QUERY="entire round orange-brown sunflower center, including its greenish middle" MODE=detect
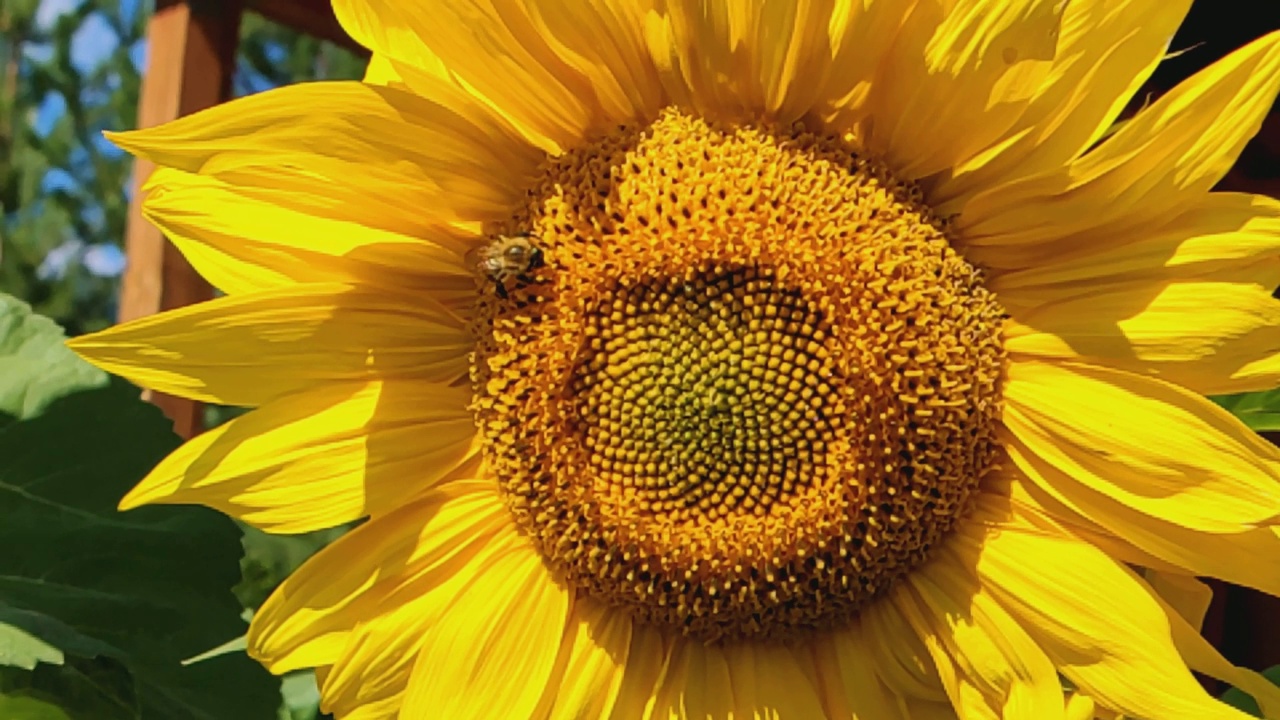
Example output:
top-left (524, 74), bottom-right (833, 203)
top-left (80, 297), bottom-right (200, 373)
top-left (472, 110), bottom-right (1004, 641)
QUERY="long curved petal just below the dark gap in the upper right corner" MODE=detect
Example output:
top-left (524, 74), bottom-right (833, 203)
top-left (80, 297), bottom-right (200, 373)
top-left (956, 32), bottom-right (1280, 256)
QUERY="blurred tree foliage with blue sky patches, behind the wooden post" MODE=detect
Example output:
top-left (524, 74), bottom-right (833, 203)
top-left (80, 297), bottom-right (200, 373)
top-left (0, 0), bottom-right (364, 334)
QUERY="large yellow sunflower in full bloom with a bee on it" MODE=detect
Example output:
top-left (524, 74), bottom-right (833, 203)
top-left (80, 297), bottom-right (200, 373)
top-left (73, 0), bottom-right (1280, 720)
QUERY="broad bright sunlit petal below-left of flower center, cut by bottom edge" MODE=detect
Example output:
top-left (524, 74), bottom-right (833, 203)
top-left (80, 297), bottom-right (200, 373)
top-left (401, 541), bottom-right (572, 720)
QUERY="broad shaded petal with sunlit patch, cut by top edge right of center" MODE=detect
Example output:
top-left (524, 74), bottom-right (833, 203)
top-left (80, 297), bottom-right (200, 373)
top-left (869, 0), bottom-right (1066, 179)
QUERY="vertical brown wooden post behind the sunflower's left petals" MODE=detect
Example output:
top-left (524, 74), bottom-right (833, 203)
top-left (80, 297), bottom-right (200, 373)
top-left (120, 0), bottom-right (242, 438)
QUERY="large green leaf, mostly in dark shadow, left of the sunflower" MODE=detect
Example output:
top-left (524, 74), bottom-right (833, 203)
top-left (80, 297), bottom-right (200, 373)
top-left (0, 295), bottom-right (280, 720)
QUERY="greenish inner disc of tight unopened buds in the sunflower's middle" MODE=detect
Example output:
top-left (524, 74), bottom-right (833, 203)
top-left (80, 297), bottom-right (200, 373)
top-left (571, 268), bottom-right (840, 523)
